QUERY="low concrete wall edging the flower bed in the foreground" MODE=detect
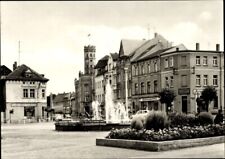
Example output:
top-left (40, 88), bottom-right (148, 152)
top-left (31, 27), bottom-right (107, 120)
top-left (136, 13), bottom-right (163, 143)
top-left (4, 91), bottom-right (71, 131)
top-left (96, 136), bottom-right (224, 151)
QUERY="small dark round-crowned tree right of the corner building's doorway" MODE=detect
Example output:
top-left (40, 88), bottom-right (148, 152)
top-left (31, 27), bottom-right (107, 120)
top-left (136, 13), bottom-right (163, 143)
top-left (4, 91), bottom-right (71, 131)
top-left (201, 86), bottom-right (217, 112)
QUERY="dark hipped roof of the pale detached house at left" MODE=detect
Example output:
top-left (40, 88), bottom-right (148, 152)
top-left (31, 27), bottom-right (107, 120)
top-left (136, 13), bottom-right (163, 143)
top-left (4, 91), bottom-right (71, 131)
top-left (6, 64), bottom-right (48, 82)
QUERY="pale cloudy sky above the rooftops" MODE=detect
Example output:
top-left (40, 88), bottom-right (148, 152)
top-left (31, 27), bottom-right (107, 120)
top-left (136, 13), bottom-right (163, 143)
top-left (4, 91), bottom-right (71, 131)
top-left (0, 0), bottom-right (224, 94)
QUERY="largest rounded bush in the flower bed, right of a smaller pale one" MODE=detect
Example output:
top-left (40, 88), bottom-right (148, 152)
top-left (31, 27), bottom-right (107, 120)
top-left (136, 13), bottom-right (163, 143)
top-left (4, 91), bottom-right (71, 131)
top-left (145, 111), bottom-right (168, 131)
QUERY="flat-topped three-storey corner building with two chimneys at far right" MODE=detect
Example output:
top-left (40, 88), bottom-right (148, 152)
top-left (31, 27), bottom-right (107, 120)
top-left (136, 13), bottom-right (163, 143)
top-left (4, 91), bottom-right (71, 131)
top-left (160, 43), bottom-right (224, 113)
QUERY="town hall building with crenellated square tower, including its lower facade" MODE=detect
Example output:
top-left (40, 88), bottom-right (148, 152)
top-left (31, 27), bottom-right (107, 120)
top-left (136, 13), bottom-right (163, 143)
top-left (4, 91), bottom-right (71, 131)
top-left (72, 45), bottom-right (96, 118)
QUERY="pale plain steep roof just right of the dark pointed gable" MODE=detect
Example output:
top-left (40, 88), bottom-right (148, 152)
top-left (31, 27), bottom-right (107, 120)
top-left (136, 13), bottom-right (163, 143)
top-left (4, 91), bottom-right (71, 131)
top-left (119, 39), bottom-right (146, 56)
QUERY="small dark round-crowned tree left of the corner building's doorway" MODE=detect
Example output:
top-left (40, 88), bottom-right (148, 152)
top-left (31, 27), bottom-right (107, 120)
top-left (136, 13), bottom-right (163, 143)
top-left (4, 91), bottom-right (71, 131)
top-left (159, 88), bottom-right (176, 113)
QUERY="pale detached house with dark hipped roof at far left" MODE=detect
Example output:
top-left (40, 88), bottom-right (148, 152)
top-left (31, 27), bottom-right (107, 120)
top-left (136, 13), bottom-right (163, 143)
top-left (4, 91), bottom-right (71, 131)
top-left (0, 63), bottom-right (48, 122)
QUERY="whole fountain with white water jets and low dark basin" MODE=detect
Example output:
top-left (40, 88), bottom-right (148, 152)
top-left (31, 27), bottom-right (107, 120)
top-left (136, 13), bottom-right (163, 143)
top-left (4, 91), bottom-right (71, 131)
top-left (55, 79), bottom-right (130, 131)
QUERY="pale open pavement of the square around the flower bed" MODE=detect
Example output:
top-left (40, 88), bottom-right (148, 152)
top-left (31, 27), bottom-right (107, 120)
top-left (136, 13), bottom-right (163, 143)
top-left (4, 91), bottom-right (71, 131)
top-left (1, 122), bottom-right (225, 159)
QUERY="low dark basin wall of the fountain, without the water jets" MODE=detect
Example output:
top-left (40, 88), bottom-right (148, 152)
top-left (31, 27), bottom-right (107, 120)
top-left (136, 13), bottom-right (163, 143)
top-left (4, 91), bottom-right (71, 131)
top-left (55, 120), bottom-right (130, 131)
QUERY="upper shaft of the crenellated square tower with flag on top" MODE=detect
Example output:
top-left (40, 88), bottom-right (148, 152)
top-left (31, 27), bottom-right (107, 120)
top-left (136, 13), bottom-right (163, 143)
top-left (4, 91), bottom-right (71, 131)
top-left (84, 45), bottom-right (96, 75)
